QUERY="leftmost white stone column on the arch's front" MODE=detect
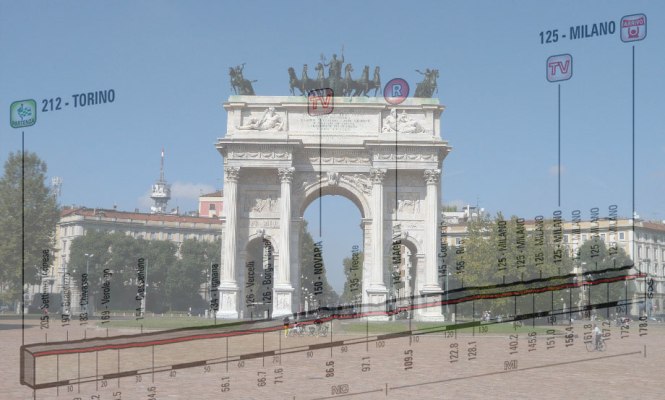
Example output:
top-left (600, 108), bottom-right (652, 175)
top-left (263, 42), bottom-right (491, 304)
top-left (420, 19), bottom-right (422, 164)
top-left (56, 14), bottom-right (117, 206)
top-left (217, 167), bottom-right (240, 319)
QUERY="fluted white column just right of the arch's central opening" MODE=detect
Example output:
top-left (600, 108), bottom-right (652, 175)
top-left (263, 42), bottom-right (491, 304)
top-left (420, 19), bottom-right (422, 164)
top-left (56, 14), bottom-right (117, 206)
top-left (366, 168), bottom-right (388, 319)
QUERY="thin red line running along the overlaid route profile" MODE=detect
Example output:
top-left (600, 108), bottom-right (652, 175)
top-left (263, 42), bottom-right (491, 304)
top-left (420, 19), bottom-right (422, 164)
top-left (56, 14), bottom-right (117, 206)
top-left (33, 273), bottom-right (646, 357)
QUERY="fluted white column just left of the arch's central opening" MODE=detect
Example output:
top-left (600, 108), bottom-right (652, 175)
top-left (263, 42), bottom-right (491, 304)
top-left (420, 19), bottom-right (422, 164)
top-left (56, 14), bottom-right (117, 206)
top-left (272, 167), bottom-right (295, 317)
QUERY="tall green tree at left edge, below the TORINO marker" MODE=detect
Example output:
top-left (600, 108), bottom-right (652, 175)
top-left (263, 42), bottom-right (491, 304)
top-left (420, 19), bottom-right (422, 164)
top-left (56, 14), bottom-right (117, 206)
top-left (0, 152), bottom-right (59, 301)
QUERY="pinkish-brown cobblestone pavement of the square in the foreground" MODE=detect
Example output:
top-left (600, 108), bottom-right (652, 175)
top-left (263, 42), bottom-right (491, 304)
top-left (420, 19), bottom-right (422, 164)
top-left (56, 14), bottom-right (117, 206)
top-left (0, 320), bottom-right (665, 400)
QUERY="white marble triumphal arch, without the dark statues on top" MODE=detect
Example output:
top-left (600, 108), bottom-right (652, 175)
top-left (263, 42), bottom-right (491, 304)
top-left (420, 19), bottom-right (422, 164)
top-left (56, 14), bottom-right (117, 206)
top-left (216, 95), bottom-right (450, 320)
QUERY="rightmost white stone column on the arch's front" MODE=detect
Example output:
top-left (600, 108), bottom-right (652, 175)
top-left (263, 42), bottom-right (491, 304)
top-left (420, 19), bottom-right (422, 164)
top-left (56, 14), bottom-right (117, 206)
top-left (420, 169), bottom-right (443, 320)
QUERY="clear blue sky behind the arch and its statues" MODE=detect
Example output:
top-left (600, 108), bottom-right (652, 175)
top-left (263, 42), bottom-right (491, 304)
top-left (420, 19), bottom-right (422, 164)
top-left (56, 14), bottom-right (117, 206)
top-left (0, 0), bottom-right (665, 289)
